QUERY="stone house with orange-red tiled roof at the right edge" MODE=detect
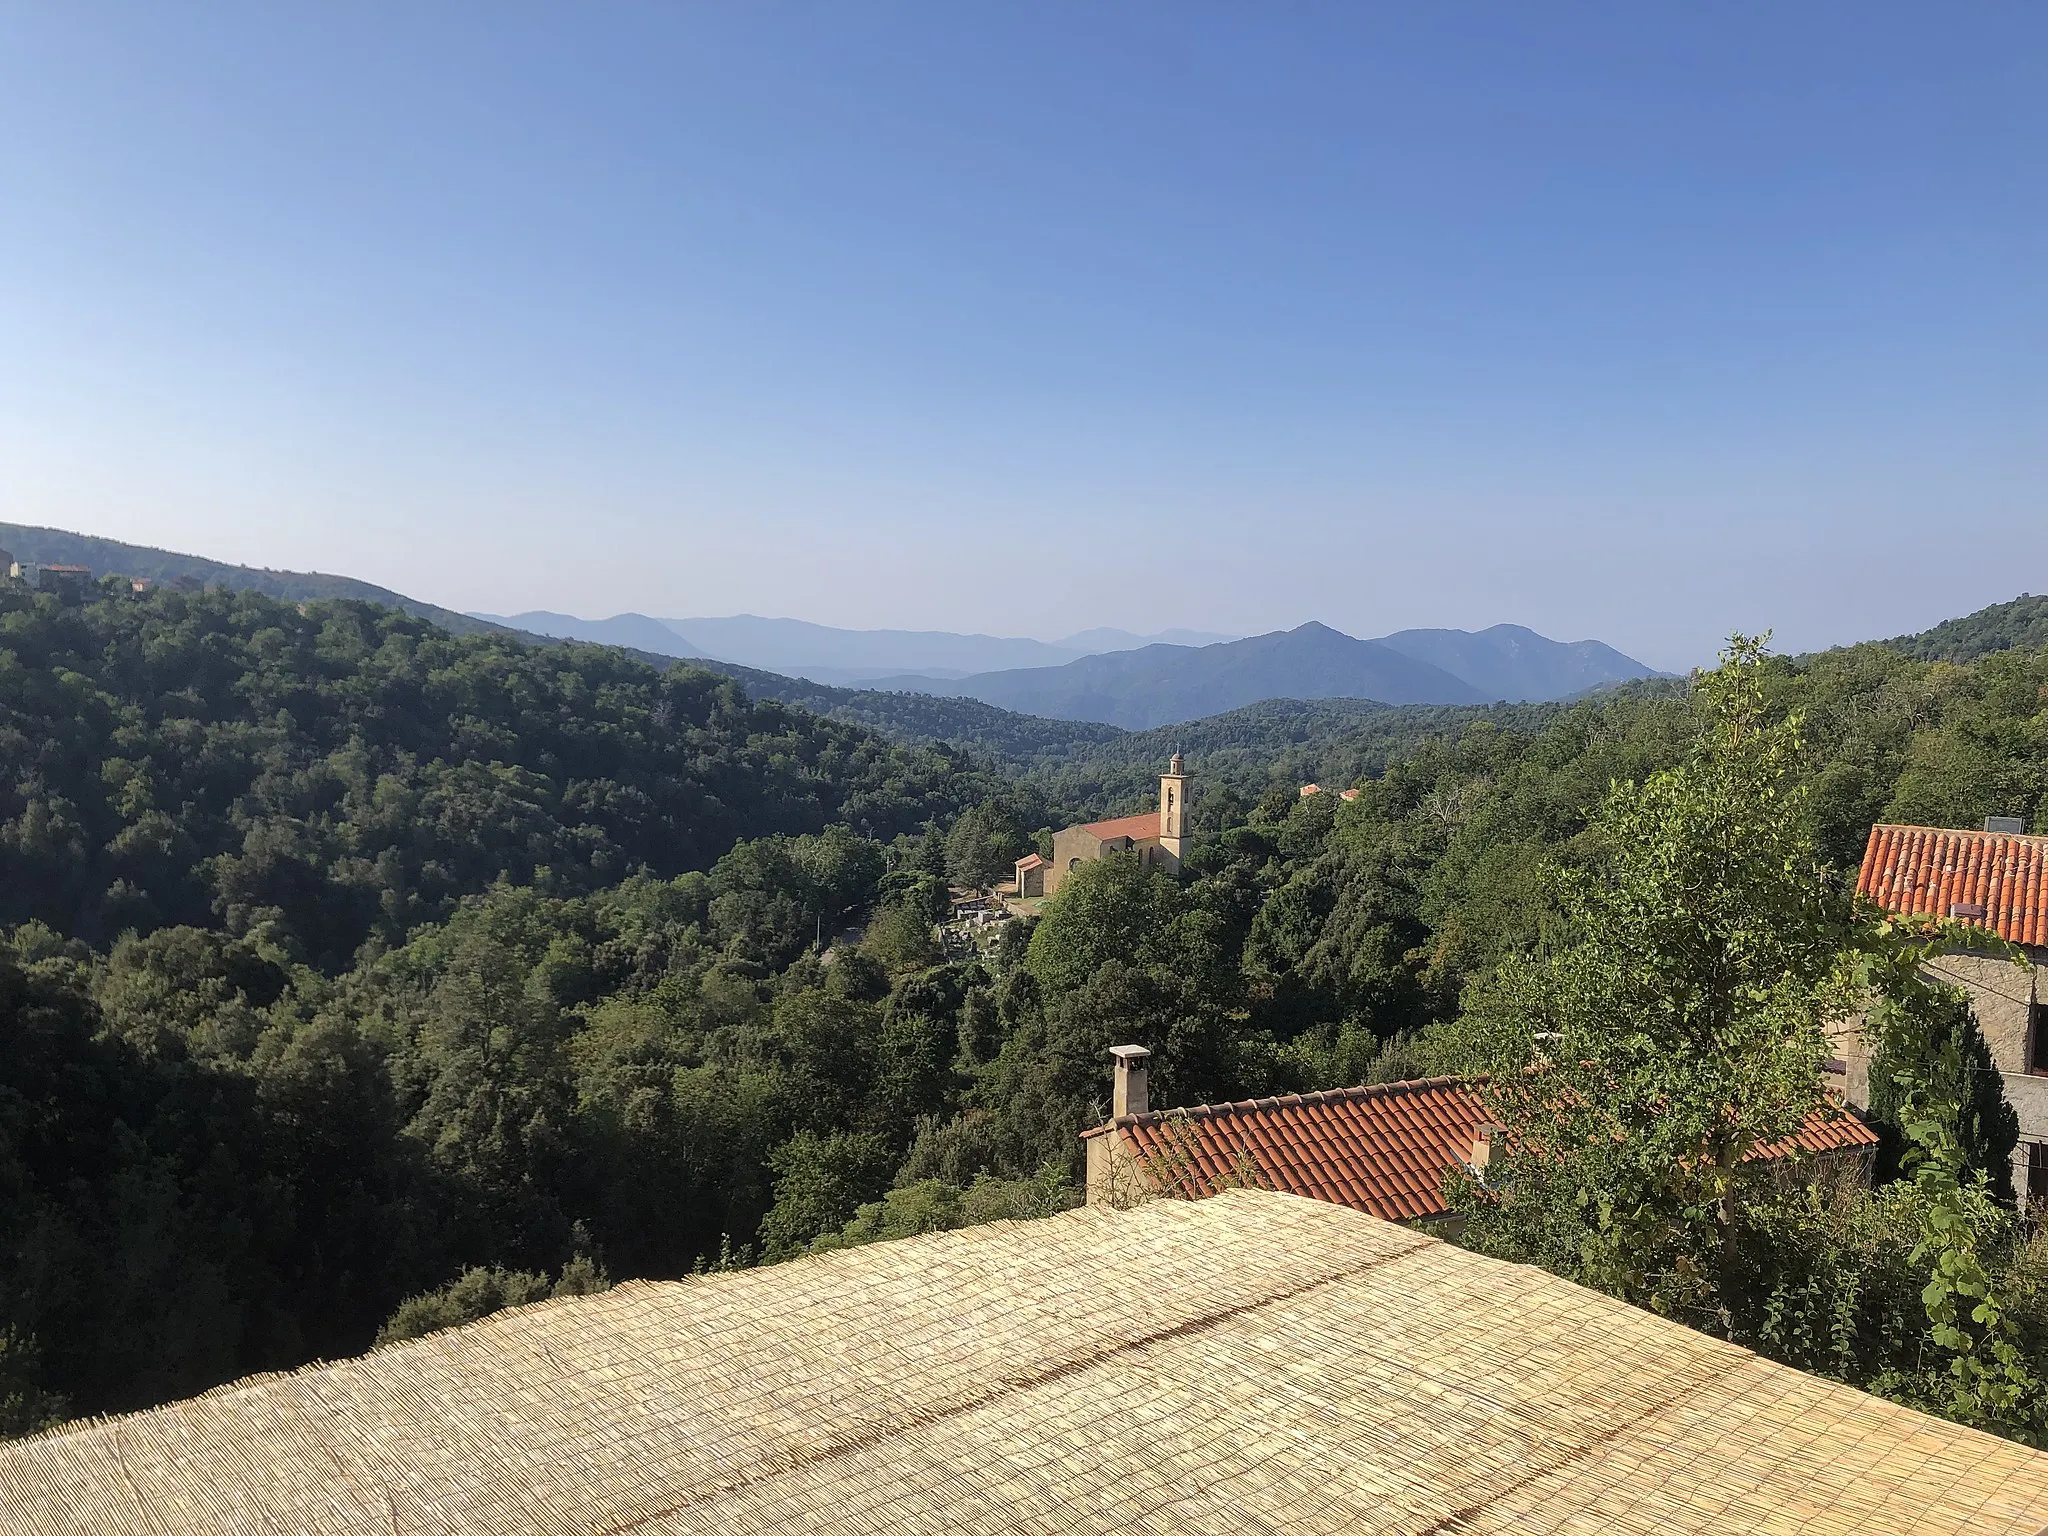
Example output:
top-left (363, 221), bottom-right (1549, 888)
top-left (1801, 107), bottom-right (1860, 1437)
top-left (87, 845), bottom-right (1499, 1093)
top-left (1831, 817), bottom-right (2048, 1200)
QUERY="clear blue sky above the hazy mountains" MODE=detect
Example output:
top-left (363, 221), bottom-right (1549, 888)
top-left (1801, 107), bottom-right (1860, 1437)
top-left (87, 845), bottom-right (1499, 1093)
top-left (0, 0), bottom-right (2048, 666)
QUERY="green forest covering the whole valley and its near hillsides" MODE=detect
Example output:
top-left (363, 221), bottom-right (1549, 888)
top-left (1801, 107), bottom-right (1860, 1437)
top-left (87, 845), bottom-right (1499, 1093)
top-left (0, 584), bottom-right (2048, 1434)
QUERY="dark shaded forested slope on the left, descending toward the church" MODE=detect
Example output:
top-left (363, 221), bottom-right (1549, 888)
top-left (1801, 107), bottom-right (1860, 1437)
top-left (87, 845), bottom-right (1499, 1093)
top-left (0, 590), bottom-right (987, 969)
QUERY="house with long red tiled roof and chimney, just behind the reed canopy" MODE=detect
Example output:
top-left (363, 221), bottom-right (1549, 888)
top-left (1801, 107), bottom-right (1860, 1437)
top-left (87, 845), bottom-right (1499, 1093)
top-left (1081, 1044), bottom-right (1878, 1223)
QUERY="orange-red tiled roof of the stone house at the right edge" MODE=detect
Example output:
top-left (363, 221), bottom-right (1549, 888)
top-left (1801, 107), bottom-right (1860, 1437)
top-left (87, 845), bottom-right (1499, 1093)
top-left (1855, 825), bottom-right (2048, 944)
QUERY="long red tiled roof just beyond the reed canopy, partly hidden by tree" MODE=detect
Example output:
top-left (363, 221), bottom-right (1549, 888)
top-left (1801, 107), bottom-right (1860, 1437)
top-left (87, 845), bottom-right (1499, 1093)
top-left (1081, 1077), bottom-right (1878, 1221)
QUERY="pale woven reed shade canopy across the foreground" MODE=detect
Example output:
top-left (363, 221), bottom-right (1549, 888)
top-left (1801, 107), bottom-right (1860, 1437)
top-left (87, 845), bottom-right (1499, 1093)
top-left (0, 1190), bottom-right (2048, 1536)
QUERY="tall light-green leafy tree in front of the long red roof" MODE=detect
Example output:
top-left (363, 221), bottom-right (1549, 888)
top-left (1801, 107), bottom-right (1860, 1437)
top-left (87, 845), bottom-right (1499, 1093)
top-left (1446, 637), bottom-right (1855, 1335)
